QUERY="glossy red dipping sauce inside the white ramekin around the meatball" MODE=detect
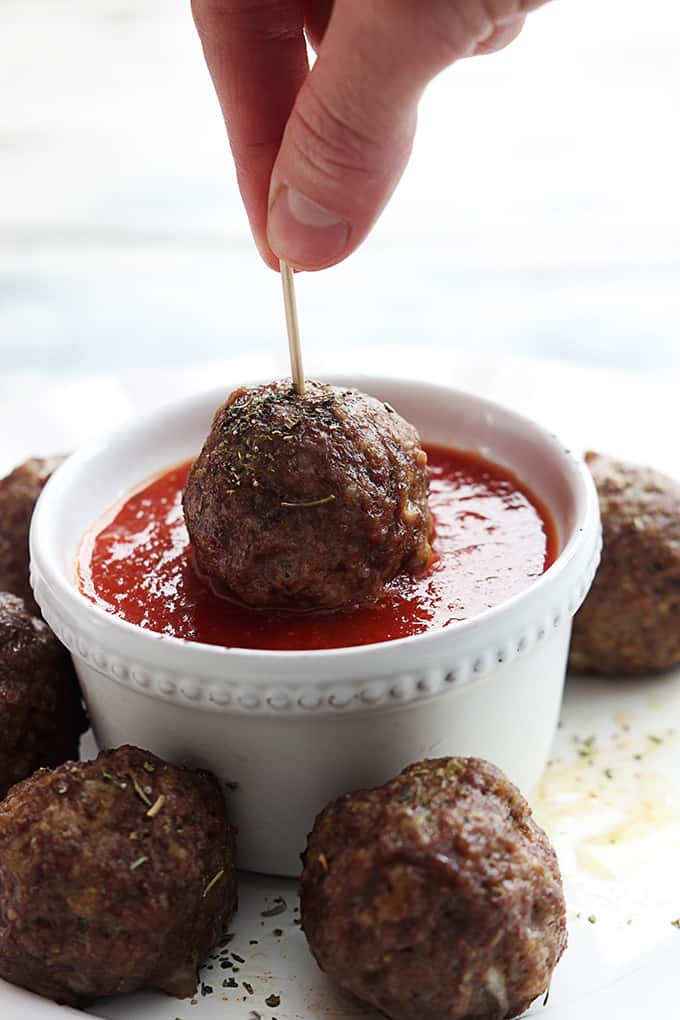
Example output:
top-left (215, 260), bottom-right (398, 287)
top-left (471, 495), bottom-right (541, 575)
top-left (79, 445), bottom-right (557, 650)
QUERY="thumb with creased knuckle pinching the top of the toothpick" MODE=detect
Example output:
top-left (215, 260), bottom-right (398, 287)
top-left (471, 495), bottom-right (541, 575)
top-left (267, 0), bottom-right (431, 269)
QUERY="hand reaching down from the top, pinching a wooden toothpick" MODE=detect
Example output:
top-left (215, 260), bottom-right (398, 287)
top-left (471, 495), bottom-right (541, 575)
top-left (193, 0), bottom-right (554, 269)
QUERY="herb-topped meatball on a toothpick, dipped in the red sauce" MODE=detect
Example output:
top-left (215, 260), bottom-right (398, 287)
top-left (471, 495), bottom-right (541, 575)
top-left (184, 381), bottom-right (432, 609)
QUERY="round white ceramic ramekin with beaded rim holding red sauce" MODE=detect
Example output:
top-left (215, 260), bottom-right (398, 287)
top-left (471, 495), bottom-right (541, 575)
top-left (31, 377), bottom-right (600, 875)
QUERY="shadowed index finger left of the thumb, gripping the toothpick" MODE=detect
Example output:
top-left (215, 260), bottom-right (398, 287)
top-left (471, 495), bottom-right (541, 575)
top-left (192, 0), bottom-right (309, 268)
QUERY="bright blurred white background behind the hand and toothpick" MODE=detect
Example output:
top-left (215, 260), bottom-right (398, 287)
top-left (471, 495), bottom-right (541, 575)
top-left (0, 0), bottom-right (680, 381)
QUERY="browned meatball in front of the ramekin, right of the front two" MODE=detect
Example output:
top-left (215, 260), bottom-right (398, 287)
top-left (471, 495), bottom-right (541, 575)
top-left (301, 758), bottom-right (567, 1020)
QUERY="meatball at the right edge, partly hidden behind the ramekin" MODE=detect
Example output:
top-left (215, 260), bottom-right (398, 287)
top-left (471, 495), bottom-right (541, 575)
top-left (570, 453), bottom-right (680, 673)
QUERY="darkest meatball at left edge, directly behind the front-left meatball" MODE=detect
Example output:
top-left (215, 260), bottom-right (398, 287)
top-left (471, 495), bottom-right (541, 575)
top-left (0, 593), bottom-right (88, 796)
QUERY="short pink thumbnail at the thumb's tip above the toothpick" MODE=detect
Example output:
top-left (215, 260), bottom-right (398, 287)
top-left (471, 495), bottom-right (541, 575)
top-left (267, 185), bottom-right (350, 269)
